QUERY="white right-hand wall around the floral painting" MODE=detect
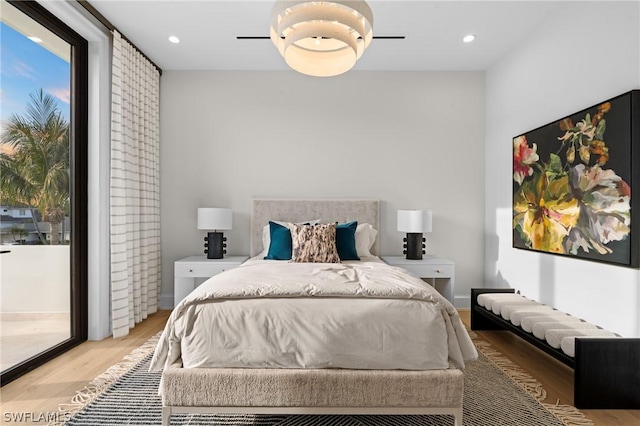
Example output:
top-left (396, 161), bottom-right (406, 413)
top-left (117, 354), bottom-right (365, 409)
top-left (485, 1), bottom-right (640, 336)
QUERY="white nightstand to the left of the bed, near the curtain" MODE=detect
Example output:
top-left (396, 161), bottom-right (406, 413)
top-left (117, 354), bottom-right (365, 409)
top-left (173, 256), bottom-right (249, 307)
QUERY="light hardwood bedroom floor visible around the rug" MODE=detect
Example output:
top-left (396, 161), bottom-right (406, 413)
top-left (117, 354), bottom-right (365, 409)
top-left (0, 311), bottom-right (640, 426)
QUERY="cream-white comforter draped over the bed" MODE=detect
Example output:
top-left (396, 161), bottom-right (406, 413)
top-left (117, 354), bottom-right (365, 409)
top-left (150, 258), bottom-right (477, 371)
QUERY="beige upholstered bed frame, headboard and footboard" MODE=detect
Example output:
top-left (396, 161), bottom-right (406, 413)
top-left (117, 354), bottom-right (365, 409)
top-left (160, 199), bottom-right (464, 426)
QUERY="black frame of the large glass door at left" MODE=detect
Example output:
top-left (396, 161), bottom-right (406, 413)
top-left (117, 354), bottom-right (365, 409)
top-left (0, 0), bottom-right (89, 386)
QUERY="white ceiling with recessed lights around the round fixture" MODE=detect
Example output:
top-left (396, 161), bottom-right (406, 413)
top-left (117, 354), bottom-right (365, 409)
top-left (84, 0), bottom-right (564, 71)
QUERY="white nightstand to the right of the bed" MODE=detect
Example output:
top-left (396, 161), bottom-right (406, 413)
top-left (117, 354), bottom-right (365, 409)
top-left (381, 255), bottom-right (456, 303)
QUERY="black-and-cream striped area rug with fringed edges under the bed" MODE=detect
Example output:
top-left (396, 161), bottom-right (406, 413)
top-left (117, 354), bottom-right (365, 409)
top-left (51, 332), bottom-right (593, 426)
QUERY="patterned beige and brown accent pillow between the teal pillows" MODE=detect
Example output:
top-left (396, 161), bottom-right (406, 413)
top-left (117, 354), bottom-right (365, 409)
top-left (289, 223), bottom-right (340, 263)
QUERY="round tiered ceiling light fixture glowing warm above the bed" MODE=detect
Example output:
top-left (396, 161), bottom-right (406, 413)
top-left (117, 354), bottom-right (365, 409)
top-left (270, 0), bottom-right (373, 77)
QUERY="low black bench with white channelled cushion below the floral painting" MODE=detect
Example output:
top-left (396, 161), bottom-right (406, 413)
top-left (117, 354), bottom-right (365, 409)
top-left (471, 288), bottom-right (640, 410)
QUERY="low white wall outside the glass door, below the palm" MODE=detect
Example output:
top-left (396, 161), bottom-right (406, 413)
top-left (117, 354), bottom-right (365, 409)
top-left (0, 245), bottom-right (71, 313)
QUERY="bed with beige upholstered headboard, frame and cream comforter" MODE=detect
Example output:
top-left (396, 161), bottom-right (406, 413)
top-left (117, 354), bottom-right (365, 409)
top-left (151, 199), bottom-right (477, 425)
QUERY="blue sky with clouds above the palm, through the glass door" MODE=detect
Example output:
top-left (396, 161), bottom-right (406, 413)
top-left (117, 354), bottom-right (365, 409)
top-left (0, 22), bottom-right (70, 135)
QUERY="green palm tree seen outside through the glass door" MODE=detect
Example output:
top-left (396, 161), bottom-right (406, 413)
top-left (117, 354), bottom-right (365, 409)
top-left (0, 89), bottom-right (69, 245)
